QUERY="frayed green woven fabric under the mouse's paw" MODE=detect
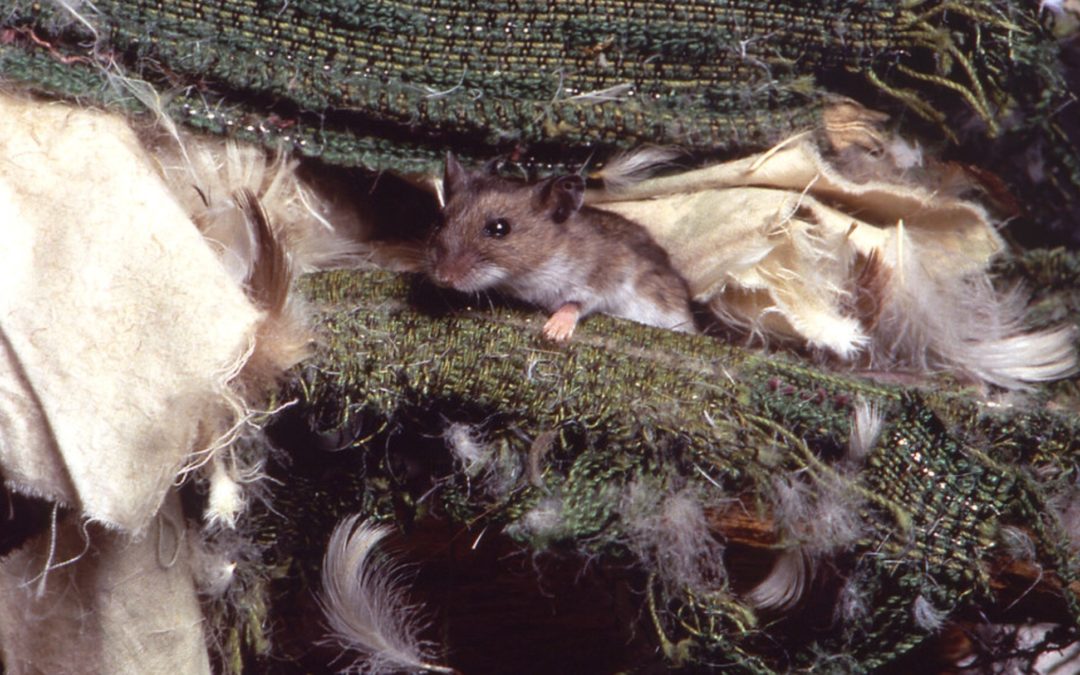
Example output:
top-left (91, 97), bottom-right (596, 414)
top-left (223, 273), bottom-right (1080, 672)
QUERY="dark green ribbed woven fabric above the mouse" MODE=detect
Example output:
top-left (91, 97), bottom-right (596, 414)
top-left (0, 0), bottom-right (1062, 176)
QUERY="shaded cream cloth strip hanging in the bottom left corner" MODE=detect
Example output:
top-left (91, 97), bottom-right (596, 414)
top-left (0, 495), bottom-right (211, 675)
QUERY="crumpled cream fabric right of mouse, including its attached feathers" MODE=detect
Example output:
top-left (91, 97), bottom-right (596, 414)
top-left (588, 135), bottom-right (1076, 387)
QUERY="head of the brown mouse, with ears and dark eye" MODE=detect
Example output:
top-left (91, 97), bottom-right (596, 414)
top-left (428, 154), bottom-right (585, 292)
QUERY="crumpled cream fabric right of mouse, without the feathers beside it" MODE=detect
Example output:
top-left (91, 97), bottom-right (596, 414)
top-left (589, 138), bottom-right (1001, 357)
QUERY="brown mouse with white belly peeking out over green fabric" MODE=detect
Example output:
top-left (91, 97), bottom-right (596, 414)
top-left (427, 154), bottom-right (696, 341)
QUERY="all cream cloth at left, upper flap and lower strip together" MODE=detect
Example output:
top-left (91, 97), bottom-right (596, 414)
top-left (0, 96), bottom-right (260, 674)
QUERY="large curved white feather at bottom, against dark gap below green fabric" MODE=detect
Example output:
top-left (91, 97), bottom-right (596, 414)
top-left (320, 515), bottom-right (454, 674)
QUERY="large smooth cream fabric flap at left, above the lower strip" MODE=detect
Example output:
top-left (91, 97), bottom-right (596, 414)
top-left (0, 97), bottom-right (258, 532)
